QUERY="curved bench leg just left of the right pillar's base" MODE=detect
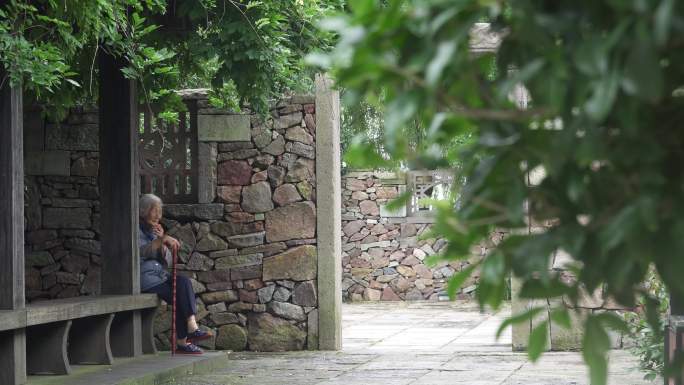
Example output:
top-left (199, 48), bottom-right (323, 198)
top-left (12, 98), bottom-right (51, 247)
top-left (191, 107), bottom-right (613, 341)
top-left (69, 314), bottom-right (114, 365)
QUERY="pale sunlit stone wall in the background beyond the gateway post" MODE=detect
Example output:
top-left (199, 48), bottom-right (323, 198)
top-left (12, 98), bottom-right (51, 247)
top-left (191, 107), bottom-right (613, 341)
top-left (342, 171), bottom-right (487, 301)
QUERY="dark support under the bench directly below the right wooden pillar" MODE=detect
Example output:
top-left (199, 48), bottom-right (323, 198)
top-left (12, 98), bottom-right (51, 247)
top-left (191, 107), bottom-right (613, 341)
top-left (109, 310), bottom-right (142, 357)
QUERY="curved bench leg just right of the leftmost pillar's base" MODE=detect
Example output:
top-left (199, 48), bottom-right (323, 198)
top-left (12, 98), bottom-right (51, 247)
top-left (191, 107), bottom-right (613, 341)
top-left (26, 321), bottom-right (71, 374)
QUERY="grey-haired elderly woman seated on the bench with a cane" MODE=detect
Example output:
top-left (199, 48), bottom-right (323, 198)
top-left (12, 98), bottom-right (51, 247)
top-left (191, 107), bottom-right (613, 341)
top-left (138, 194), bottom-right (211, 354)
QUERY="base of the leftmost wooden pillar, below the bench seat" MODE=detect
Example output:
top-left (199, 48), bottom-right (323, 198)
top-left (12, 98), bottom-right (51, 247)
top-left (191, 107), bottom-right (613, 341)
top-left (0, 329), bottom-right (26, 385)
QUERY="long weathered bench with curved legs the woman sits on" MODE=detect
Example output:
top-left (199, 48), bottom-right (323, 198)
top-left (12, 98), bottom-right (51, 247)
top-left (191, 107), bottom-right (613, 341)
top-left (0, 294), bottom-right (159, 374)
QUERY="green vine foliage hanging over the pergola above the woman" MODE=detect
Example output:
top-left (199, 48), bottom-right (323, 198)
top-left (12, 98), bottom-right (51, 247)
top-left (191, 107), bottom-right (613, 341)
top-left (0, 0), bottom-right (344, 118)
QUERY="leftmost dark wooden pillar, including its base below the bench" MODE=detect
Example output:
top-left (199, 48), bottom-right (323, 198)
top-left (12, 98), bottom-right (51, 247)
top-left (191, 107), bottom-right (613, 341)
top-left (0, 66), bottom-right (26, 384)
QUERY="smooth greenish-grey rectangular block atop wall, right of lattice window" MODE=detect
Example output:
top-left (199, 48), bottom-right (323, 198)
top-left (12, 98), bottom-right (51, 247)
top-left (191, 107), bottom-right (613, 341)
top-left (197, 114), bottom-right (251, 142)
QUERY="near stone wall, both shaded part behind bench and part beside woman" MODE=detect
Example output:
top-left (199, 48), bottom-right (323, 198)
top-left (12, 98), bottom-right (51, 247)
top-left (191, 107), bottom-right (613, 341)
top-left (20, 91), bottom-right (318, 351)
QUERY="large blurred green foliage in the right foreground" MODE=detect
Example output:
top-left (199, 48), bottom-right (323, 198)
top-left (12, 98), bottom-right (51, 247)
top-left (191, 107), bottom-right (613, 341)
top-left (316, 0), bottom-right (684, 384)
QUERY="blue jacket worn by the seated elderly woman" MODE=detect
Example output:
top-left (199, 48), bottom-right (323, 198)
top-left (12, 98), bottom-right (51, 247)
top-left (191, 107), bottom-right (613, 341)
top-left (138, 224), bottom-right (171, 291)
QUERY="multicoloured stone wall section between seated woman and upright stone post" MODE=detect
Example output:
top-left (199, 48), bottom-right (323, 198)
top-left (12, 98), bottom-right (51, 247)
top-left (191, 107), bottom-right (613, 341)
top-left (157, 93), bottom-right (317, 351)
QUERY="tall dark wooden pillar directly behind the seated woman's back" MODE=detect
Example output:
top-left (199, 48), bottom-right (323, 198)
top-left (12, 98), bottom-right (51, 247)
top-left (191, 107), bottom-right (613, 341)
top-left (99, 50), bottom-right (142, 357)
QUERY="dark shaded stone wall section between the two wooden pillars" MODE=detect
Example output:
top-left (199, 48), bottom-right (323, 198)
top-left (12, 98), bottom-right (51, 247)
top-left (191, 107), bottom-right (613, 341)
top-left (24, 108), bottom-right (101, 301)
